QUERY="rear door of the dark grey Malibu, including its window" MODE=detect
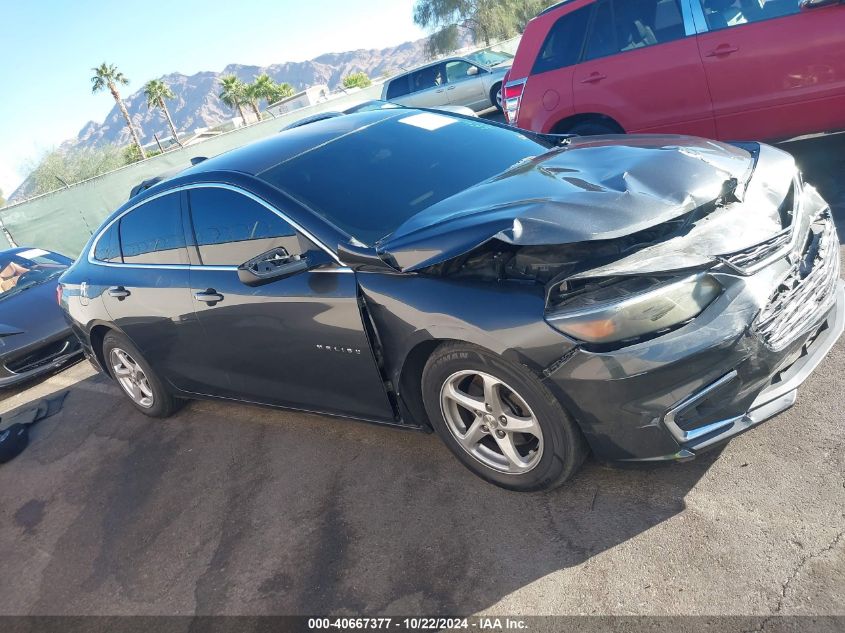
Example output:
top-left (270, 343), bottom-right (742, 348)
top-left (95, 192), bottom-right (202, 390)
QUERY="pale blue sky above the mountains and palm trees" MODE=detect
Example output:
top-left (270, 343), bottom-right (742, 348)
top-left (0, 0), bottom-right (425, 197)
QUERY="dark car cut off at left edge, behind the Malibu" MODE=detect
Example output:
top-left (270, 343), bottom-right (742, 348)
top-left (0, 248), bottom-right (82, 387)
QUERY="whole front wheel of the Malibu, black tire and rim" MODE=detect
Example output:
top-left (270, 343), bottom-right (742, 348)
top-left (422, 343), bottom-right (589, 491)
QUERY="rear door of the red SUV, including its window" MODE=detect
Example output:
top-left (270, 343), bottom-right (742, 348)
top-left (573, 0), bottom-right (715, 137)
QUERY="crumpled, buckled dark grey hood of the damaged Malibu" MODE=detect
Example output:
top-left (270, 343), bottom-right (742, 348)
top-left (377, 135), bottom-right (794, 271)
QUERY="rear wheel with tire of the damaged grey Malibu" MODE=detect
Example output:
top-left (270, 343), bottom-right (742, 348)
top-left (103, 332), bottom-right (182, 418)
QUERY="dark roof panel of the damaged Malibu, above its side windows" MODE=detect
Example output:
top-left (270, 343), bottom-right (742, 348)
top-left (181, 108), bottom-right (412, 177)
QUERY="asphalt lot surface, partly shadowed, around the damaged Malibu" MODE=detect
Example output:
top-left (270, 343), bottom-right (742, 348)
top-left (0, 135), bottom-right (845, 616)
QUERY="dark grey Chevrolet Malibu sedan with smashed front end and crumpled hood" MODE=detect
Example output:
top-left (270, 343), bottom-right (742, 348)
top-left (61, 109), bottom-right (845, 490)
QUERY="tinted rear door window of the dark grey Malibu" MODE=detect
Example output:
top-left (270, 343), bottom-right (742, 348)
top-left (120, 193), bottom-right (188, 264)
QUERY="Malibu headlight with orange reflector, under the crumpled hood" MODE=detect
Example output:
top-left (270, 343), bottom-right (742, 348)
top-left (546, 273), bottom-right (722, 343)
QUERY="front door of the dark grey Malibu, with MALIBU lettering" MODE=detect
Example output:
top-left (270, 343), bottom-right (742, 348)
top-left (183, 187), bottom-right (393, 421)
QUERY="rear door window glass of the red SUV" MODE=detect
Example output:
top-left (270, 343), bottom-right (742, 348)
top-left (584, 0), bottom-right (686, 59)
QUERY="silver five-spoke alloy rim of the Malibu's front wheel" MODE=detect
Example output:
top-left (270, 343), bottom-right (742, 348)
top-left (440, 370), bottom-right (543, 474)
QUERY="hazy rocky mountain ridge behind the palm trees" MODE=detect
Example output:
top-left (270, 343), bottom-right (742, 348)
top-left (74, 39), bottom-right (436, 147)
